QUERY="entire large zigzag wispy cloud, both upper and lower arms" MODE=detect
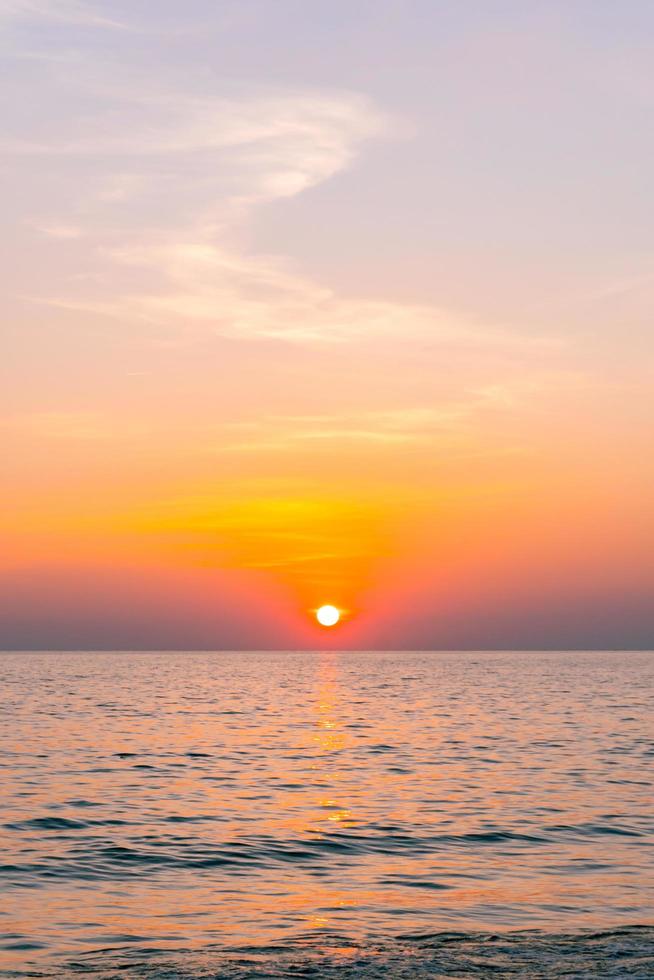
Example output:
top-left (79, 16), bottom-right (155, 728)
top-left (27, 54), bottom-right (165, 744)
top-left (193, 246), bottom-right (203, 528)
top-left (4, 46), bottom-right (556, 364)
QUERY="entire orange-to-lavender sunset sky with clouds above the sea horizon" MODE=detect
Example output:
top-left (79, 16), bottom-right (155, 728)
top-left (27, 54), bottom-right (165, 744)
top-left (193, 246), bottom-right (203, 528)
top-left (0, 0), bottom-right (654, 649)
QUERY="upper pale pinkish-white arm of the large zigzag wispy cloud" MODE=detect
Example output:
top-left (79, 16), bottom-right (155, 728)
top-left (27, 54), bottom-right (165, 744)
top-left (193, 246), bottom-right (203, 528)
top-left (0, 74), bottom-right (386, 212)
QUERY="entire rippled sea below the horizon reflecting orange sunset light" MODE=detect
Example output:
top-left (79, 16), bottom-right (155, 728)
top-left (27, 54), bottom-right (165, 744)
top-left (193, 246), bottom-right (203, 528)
top-left (0, 652), bottom-right (654, 978)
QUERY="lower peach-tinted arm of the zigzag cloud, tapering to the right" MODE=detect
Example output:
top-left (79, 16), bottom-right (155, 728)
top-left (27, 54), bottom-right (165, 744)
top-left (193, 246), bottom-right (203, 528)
top-left (43, 229), bottom-right (560, 352)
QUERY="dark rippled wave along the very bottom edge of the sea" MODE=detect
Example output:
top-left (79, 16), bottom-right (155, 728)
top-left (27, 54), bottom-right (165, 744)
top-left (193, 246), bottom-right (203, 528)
top-left (30, 926), bottom-right (654, 980)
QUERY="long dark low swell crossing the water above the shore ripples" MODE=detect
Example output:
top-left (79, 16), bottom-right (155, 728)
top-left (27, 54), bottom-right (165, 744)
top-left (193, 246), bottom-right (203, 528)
top-left (0, 814), bottom-right (643, 888)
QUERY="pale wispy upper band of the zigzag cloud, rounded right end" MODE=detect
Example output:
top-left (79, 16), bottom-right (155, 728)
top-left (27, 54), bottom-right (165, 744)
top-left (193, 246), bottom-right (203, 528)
top-left (2, 89), bottom-right (383, 203)
